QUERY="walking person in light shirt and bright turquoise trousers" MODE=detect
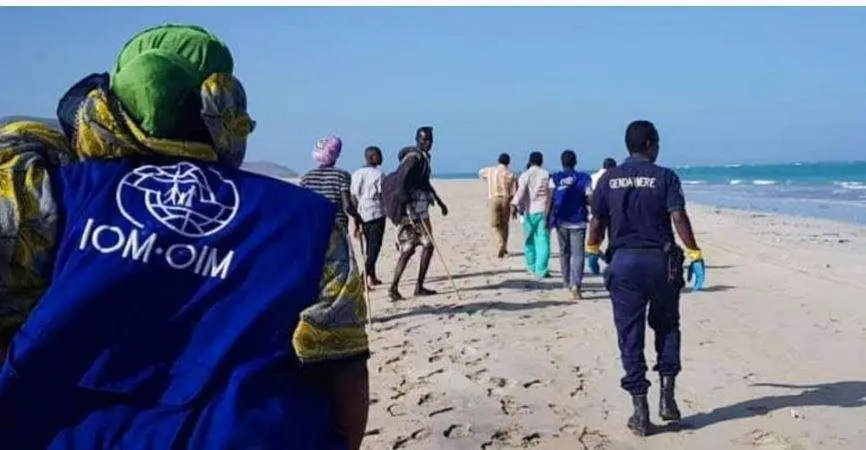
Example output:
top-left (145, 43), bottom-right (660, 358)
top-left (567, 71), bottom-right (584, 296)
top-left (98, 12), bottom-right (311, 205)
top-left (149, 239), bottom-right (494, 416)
top-left (511, 152), bottom-right (550, 278)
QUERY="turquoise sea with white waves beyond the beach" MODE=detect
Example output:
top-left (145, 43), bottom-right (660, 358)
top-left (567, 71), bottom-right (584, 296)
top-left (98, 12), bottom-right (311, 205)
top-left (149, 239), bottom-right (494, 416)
top-left (438, 161), bottom-right (866, 225)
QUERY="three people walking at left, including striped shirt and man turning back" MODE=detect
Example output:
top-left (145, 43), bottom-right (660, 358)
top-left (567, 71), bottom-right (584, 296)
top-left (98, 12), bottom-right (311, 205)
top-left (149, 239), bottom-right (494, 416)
top-left (300, 126), bottom-right (448, 301)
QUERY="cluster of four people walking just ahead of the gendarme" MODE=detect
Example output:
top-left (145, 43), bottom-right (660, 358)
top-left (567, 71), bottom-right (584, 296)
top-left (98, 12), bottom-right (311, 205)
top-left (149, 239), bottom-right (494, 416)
top-left (478, 150), bottom-right (616, 300)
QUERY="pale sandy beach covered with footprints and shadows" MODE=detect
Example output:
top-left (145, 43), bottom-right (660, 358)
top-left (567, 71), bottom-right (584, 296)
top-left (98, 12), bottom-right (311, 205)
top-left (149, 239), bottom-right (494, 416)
top-left (352, 181), bottom-right (866, 450)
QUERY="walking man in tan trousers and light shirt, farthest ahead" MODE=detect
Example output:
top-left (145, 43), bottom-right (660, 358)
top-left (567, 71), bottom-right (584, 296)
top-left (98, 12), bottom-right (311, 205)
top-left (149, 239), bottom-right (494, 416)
top-left (478, 153), bottom-right (517, 258)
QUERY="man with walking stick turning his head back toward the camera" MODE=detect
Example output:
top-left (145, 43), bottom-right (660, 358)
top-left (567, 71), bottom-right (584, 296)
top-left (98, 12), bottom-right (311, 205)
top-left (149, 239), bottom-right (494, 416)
top-left (382, 127), bottom-right (448, 301)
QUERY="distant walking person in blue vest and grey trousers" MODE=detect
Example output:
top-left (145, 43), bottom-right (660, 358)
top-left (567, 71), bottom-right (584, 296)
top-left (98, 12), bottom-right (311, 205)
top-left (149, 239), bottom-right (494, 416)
top-left (547, 150), bottom-right (592, 300)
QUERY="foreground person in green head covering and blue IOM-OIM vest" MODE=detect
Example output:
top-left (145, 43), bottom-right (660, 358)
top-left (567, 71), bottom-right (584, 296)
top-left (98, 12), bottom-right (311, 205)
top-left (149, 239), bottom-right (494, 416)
top-left (0, 25), bottom-right (369, 450)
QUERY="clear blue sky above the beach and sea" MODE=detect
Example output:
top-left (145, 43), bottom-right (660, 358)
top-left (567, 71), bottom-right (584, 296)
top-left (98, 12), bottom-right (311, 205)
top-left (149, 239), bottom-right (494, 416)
top-left (0, 7), bottom-right (866, 173)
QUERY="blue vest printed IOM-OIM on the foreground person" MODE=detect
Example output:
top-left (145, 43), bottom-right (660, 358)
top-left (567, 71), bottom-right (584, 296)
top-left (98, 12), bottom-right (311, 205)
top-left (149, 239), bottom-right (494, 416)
top-left (0, 158), bottom-right (342, 450)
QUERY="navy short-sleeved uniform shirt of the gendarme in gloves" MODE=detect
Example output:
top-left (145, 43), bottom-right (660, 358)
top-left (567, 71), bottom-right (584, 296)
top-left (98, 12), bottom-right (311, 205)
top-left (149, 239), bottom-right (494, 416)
top-left (592, 156), bottom-right (685, 250)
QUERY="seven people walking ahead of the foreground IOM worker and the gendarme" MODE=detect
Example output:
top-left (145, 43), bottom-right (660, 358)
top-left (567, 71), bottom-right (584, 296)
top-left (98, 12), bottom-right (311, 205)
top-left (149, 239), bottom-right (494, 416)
top-left (300, 127), bottom-right (616, 306)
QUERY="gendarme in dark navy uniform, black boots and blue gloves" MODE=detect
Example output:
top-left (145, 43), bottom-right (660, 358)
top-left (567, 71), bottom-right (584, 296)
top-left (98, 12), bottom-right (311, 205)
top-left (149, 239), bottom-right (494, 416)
top-left (587, 120), bottom-right (704, 436)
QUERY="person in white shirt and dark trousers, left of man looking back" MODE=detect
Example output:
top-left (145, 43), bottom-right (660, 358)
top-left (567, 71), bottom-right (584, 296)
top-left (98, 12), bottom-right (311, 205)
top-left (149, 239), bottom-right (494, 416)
top-left (351, 147), bottom-right (385, 287)
